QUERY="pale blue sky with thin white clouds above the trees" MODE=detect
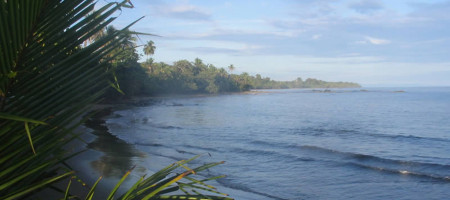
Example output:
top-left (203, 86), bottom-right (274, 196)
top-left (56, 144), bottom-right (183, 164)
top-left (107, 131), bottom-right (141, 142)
top-left (99, 0), bottom-right (450, 86)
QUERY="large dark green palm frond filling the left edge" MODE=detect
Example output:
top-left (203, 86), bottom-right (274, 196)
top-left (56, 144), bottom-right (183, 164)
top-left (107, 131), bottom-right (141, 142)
top-left (0, 0), bottom-right (139, 199)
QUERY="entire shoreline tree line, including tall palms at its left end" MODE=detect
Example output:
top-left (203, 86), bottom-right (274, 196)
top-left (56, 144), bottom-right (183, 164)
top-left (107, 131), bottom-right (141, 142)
top-left (102, 26), bottom-right (361, 99)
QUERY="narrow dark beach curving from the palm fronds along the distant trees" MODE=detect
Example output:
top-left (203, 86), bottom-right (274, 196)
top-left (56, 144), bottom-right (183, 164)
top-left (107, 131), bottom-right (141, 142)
top-left (68, 88), bottom-right (360, 184)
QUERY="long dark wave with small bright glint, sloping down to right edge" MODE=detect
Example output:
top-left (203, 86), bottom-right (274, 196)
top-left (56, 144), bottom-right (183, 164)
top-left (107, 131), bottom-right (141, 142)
top-left (135, 140), bottom-right (450, 182)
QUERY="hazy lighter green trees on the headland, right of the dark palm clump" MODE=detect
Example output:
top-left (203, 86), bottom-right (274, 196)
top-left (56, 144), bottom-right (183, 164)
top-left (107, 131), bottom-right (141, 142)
top-left (136, 58), bottom-right (360, 94)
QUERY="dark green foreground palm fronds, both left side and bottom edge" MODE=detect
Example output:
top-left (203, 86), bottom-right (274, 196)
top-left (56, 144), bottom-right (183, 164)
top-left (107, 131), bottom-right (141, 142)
top-left (0, 0), bottom-right (229, 200)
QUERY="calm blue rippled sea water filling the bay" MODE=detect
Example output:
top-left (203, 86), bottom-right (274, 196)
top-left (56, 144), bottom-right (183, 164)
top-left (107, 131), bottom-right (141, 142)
top-left (103, 87), bottom-right (450, 199)
